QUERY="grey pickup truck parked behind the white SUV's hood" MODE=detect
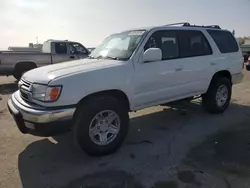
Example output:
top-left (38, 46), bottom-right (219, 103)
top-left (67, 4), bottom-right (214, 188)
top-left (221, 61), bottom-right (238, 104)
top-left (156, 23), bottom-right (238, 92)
top-left (0, 40), bottom-right (90, 80)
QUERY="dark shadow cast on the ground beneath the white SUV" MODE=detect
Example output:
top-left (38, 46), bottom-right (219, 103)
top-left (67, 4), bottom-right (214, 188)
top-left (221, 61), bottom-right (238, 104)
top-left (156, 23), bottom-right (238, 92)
top-left (18, 102), bottom-right (250, 188)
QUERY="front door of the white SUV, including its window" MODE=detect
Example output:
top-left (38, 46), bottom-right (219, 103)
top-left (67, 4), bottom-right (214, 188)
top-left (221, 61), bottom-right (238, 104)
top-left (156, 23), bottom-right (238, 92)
top-left (134, 30), bottom-right (182, 108)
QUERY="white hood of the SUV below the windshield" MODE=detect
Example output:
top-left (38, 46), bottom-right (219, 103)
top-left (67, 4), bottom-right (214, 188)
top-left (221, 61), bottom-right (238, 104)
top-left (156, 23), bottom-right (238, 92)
top-left (22, 59), bottom-right (123, 84)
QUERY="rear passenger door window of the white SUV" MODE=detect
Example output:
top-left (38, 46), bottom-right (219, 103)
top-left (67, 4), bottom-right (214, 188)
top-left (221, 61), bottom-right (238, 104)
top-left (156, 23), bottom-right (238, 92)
top-left (179, 30), bottom-right (212, 57)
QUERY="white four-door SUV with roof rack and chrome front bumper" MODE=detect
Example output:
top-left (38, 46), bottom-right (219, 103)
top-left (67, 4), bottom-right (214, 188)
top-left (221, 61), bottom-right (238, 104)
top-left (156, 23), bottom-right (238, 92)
top-left (8, 23), bottom-right (243, 155)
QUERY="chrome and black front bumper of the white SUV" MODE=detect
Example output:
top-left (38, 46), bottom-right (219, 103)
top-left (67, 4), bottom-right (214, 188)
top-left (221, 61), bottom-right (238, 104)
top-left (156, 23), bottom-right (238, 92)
top-left (7, 91), bottom-right (75, 136)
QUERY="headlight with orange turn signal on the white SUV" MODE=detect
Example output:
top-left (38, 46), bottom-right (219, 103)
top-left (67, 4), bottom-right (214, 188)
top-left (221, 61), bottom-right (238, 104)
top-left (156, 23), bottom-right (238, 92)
top-left (32, 84), bottom-right (62, 102)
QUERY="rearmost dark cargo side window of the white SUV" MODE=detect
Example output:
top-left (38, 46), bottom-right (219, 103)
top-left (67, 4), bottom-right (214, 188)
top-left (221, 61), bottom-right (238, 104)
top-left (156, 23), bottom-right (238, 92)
top-left (207, 30), bottom-right (239, 53)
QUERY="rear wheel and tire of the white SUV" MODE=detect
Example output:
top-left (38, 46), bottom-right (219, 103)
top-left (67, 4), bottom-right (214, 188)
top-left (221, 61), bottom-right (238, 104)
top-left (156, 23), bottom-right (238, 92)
top-left (202, 77), bottom-right (232, 114)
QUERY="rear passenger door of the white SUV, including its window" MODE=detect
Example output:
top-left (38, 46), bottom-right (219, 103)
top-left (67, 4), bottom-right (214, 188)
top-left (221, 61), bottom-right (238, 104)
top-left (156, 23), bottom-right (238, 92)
top-left (178, 30), bottom-right (213, 97)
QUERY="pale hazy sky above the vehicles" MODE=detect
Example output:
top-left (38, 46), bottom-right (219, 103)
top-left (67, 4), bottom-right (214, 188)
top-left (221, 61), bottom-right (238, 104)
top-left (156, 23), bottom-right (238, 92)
top-left (0, 0), bottom-right (250, 49)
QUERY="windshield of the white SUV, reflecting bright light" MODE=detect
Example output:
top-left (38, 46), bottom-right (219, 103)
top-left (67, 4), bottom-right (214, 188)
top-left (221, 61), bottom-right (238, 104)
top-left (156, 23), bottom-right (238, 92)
top-left (90, 30), bottom-right (145, 60)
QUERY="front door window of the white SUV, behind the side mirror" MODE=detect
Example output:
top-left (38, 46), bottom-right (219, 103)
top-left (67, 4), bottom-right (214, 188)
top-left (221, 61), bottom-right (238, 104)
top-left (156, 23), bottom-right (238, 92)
top-left (144, 31), bottom-right (179, 60)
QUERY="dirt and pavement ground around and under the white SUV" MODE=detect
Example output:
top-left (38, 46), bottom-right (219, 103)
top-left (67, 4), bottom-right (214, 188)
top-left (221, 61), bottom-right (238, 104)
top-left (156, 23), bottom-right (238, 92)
top-left (0, 73), bottom-right (250, 188)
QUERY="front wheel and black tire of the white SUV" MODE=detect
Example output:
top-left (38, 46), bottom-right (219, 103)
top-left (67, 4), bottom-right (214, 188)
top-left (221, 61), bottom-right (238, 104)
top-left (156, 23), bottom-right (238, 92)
top-left (74, 97), bottom-right (129, 156)
